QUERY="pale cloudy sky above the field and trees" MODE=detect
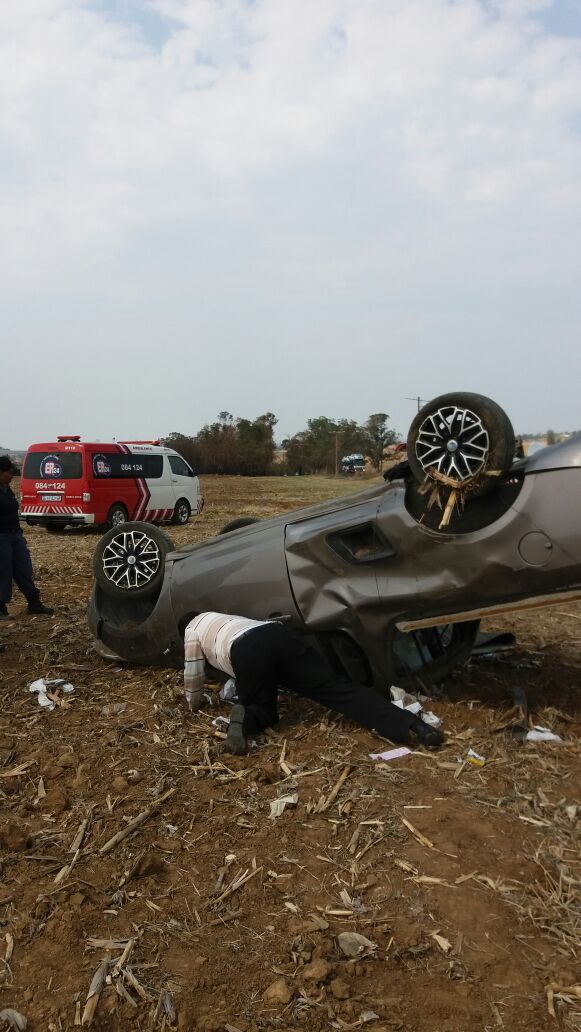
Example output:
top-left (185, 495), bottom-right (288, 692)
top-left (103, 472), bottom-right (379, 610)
top-left (0, 0), bottom-right (581, 448)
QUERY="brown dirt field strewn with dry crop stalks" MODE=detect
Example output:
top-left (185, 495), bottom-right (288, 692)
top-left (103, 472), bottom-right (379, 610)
top-left (0, 477), bottom-right (581, 1032)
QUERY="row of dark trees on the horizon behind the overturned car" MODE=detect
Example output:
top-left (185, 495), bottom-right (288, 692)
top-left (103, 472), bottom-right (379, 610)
top-left (163, 412), bottom-right (397, 477)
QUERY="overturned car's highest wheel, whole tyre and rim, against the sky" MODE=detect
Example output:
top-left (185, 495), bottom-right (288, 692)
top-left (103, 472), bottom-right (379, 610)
top-left (408, 391), bottom-right (515, 496)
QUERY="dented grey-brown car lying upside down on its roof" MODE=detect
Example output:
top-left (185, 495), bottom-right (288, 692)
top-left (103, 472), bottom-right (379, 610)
top-left (89, 392), bottom-right (581, 690)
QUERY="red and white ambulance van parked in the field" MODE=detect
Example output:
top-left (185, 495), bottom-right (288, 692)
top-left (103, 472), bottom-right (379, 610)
top-left (21, 437), bottom-right (203, 530)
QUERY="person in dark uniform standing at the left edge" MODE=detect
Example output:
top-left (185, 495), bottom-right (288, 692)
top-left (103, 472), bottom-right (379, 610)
top-left (0, 455), bottom-right (54, 620)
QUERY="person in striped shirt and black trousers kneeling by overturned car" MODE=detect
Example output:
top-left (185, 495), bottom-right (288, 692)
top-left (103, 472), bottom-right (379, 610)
top-left (184, 613), bottom-right (444, 754)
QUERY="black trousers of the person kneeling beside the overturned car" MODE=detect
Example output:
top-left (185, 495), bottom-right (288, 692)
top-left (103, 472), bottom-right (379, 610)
top-left (230, 623), bottom-right (414, 742)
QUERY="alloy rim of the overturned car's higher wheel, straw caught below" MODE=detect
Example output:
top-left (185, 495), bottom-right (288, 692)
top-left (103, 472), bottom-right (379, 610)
top-left (416, 405), bottom-right (490, 483)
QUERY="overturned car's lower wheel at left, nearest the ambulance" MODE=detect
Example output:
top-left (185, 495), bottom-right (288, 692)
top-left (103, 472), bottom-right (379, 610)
top-left (93, 520), bottom-right (175, 601)
